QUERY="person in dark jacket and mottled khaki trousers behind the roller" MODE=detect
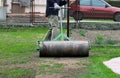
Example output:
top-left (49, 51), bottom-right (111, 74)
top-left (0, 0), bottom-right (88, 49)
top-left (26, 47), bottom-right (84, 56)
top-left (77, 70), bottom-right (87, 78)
top-left (46, 0), bottom-right (67, 40)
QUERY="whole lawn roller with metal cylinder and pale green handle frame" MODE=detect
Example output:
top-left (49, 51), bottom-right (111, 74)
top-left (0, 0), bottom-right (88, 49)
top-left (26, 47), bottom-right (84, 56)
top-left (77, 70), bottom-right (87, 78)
top-left (37, 8), bottom-right (90, 57)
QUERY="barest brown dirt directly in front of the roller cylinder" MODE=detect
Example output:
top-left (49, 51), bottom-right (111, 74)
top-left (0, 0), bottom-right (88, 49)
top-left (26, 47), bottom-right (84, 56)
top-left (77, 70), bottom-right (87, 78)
top-left (36, 57), bottom-right (89, 78)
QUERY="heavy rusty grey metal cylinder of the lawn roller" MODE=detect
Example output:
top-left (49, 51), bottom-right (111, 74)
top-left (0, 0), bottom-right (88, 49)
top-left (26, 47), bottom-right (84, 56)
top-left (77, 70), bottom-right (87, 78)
top-left (39, 41), bottom-right (89, 57)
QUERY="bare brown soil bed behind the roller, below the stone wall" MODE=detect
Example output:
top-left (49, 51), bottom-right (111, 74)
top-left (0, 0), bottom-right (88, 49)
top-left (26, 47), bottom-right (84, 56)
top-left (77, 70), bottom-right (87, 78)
top-left (71, 29), bottom-right (120, 45)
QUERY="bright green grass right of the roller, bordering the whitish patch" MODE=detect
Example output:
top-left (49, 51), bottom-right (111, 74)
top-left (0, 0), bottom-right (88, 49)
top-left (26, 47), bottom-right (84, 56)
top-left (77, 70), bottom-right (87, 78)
top-left (75, 46), bottom-right (120, 78)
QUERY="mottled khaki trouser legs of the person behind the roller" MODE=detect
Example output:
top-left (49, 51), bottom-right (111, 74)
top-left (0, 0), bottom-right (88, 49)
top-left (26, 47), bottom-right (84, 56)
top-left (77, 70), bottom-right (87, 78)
top-left (48, 15), bottom-right (59, 40)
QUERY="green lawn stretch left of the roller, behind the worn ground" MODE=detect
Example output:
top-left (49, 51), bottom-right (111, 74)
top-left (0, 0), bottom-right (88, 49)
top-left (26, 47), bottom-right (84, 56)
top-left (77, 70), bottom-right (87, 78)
top-left (0, 28), bottom-right (47, 53)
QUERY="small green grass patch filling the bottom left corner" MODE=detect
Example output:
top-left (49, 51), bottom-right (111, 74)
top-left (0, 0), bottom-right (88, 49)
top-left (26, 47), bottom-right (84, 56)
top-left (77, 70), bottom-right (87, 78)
top-left (0, 68), bottom-right (35, 78)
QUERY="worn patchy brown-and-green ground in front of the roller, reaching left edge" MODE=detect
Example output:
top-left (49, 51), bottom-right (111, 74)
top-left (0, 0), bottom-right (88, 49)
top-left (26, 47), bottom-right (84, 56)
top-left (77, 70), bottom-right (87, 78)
top-left (0, 52), bottom-right (89, 78)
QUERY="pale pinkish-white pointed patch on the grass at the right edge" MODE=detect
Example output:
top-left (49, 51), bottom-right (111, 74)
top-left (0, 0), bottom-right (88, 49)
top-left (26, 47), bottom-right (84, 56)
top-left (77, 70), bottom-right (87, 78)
top-left (103, 57), bottom-right (120, 74)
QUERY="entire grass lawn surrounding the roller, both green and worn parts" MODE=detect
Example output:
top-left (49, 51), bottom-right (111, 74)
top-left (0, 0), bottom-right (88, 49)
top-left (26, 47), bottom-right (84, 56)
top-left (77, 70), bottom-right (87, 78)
top-left (0, 27), bottom-right (120, 78)
